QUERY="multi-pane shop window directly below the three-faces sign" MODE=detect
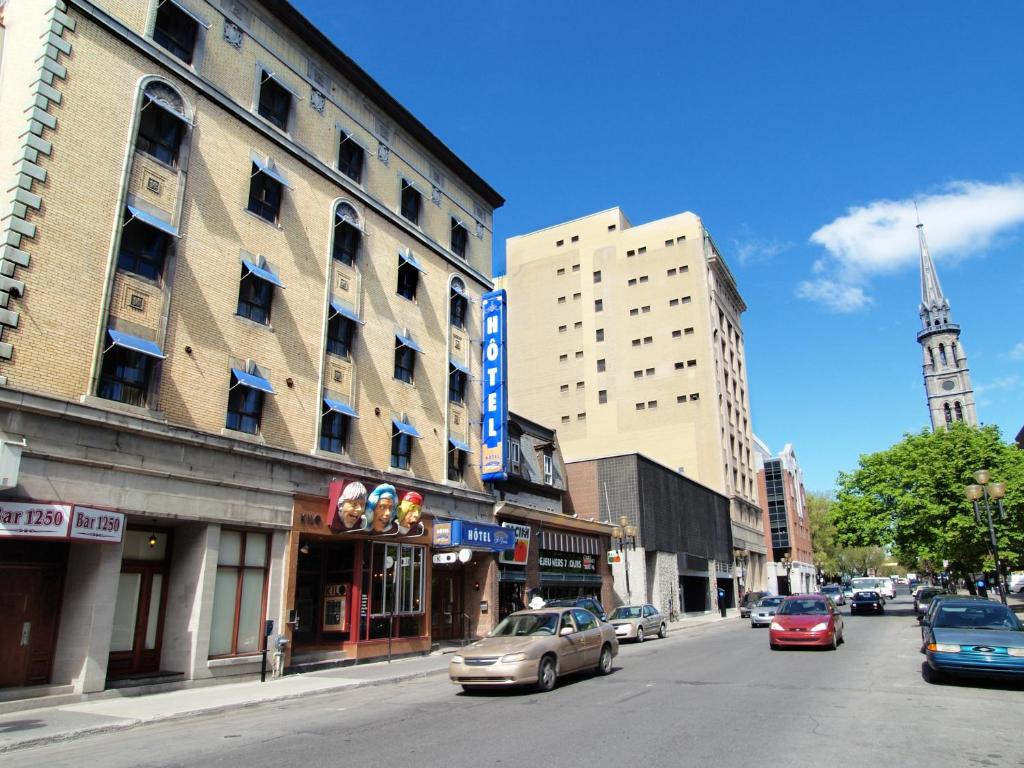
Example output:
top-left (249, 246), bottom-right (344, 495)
top-left (362, 542), bottom-right (426, 640)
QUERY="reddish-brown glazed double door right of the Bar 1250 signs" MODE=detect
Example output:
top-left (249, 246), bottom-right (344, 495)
top-left (106, 530), bottom-right (171, 680)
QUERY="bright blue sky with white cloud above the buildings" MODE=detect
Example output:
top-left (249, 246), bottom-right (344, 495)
top-left (293, 0), bottom-right (1024, 490)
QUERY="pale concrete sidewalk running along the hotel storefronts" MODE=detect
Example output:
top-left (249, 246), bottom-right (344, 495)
top-left (0, 610), bottom-right (738, 755)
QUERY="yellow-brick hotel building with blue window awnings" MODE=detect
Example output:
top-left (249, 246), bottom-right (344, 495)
top-left (0, 0), bottom-right (503, 692)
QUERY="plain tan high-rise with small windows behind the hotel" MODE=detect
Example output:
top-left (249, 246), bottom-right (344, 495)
top-left (501, 208), bottom-right (766, 590)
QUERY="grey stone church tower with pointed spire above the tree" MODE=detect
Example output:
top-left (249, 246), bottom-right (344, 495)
top-left (918, 221), bottom-right (978, 432)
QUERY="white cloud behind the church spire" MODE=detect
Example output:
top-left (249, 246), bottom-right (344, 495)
top-left (797, 179), bottom-right (1024, 312)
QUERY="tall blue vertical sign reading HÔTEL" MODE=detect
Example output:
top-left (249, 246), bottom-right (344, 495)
top-left (480, 289), bottom-right (509, 480)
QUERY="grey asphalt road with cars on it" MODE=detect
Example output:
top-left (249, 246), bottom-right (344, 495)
top-left (3, 595), bottom-right (1024, 768)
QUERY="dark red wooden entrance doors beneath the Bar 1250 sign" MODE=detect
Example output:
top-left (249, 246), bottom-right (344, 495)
top-left (0, 542), bottom-right (68, 688)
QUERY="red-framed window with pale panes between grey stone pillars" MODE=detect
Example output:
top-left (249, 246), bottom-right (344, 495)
top-left (210, 530), bottom-right (270, 656)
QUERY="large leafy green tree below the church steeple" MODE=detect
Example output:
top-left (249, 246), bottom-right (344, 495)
top-left (829, 424), bottom-right (1024, 573)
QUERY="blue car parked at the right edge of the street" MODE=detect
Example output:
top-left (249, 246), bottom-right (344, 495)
top-left (922, 598), bottom-right (1024, 683)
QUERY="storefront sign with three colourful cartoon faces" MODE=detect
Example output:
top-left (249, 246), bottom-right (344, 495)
top-left (327, 480), bottom-right (424, 537)
